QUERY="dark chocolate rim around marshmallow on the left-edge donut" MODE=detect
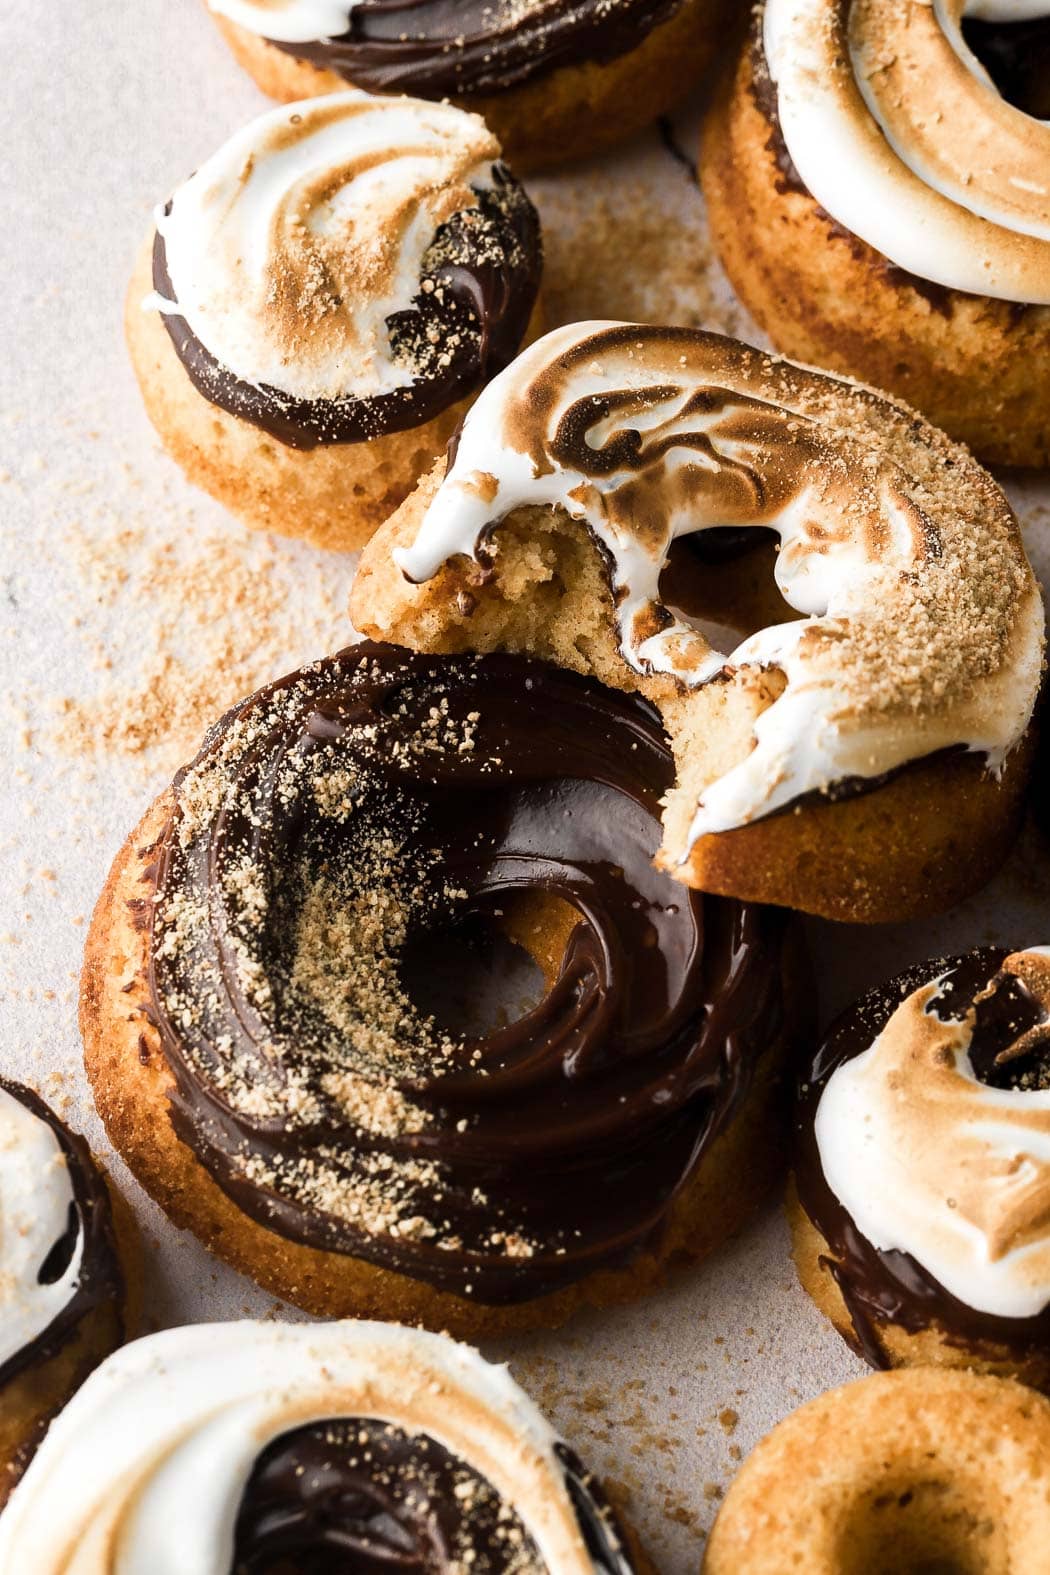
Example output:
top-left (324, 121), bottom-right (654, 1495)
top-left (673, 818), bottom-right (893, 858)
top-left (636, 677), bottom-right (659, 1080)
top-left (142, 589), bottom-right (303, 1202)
top-left (0, 1077), bottom-right (124, 1395)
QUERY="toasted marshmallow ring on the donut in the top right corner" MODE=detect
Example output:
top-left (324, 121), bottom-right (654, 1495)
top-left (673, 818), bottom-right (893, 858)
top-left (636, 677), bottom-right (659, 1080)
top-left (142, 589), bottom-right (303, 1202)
top-left (763, 0), bottom-right (1050, 304)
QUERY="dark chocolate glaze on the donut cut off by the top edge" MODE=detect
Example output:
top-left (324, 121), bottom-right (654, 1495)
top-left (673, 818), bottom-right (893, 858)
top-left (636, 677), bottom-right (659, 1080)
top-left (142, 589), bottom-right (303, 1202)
top-left (267, 0), bottom-right (682, 98)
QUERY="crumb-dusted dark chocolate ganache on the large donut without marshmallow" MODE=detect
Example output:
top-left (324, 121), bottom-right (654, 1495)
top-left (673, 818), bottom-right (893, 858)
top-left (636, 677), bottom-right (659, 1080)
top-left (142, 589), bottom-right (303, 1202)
top-left (151, 643), bottom-right (787, 1304)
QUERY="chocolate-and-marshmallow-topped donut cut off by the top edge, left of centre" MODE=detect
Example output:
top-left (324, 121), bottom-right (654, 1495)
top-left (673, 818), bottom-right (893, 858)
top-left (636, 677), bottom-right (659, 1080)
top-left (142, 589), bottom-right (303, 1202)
top-left (206, 0), bottom-right (743, 170)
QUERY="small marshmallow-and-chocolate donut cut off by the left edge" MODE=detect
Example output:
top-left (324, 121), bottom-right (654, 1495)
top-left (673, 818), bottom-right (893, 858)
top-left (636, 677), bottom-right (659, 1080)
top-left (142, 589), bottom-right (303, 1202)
top-left (0, 1077), bottom-right (140, 1499)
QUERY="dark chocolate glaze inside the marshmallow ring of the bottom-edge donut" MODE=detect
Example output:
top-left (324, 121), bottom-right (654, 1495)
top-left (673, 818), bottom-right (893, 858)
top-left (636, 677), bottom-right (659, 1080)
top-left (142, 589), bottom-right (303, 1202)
top-left (233, 1418), bottom-right (633, 1575)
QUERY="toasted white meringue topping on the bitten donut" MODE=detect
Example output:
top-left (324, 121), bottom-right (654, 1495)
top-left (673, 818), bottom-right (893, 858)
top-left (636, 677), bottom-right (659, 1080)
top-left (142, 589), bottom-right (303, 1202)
top-left (395, 323), bottom-right (1042, 843)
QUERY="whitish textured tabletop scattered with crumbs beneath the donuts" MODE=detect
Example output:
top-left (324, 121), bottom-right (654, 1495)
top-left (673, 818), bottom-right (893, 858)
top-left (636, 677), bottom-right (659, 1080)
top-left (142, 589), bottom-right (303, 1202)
top-left (0, 0), bottom-right (1050, 1575)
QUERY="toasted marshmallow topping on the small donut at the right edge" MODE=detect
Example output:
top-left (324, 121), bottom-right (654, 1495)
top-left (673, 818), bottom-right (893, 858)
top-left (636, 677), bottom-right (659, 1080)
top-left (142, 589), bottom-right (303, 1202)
top-left (815, 947), bottom-right (1050, 1318)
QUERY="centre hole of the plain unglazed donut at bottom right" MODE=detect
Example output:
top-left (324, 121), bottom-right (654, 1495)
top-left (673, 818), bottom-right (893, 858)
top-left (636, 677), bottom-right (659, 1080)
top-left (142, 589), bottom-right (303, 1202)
top-left (834, 1474), bottom-right (1011, 1575)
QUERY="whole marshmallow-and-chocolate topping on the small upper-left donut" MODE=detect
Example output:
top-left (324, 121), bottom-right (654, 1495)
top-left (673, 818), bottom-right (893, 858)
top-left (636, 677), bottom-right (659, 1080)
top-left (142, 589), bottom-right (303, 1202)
top-left (145, 91), bottom-right (540, 447)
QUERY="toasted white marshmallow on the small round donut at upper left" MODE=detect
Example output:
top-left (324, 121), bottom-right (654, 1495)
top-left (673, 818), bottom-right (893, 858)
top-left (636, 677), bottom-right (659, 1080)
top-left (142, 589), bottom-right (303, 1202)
top-left (145, 90), bottom-right (499, 400)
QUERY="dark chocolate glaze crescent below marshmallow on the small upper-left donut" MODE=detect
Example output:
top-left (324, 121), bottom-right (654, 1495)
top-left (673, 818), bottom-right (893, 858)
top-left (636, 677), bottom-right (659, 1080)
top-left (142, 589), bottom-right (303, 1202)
top-left (153, 173), bottom-right (543, 449)
